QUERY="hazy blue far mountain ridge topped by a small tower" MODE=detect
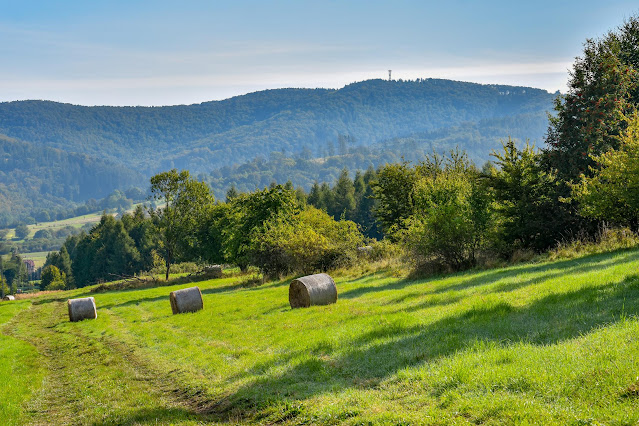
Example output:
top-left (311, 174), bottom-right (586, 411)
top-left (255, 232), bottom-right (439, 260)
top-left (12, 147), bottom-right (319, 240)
top-left (0, 79), bottom-right (553, 174)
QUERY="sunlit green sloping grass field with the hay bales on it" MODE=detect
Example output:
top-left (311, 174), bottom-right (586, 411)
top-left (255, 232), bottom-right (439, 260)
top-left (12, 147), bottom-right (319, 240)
top-left (0, 250), bottom-right (639, 425)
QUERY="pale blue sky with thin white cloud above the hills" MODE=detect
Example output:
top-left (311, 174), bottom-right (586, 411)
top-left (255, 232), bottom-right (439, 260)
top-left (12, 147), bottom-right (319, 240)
top-left (0, 0), bottom-right (639, 105)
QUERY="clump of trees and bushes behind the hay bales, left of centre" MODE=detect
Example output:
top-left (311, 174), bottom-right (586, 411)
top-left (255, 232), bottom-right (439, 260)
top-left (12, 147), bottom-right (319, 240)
top-left (42, 169), bottom-right (364, 289)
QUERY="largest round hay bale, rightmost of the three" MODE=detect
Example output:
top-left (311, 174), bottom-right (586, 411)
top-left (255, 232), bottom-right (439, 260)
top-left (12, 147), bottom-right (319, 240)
top-left (288, 274), bottom-right (337, 309)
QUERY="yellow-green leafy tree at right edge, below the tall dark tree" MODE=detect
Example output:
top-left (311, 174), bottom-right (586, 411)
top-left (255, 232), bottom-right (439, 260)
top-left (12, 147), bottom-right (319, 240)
top-left (572, 112), bottom-right (639, 226)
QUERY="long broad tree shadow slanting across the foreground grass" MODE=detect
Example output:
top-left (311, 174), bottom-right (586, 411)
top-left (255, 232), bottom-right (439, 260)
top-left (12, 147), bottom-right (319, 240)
top-left (212, 272), bottom-right (639, 416)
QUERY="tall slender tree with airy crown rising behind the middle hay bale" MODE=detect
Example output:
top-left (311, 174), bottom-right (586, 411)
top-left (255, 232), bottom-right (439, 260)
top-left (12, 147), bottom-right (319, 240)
top-left (149, 169), bottom-right (214, 281)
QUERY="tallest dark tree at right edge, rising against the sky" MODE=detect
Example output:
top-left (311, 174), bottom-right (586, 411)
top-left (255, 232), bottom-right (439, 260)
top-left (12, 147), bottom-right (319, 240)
top-left (546, 16), bottom-right (639, 181)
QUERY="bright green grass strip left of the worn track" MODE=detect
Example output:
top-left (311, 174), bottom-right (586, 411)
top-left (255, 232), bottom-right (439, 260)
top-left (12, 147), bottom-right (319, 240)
top-left (0, 301), bottom-right (45, 425)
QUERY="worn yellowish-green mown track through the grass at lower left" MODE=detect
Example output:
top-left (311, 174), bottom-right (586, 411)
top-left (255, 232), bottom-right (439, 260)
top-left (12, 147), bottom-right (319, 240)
top-left (11, 301), bottom-right (214, 424)
